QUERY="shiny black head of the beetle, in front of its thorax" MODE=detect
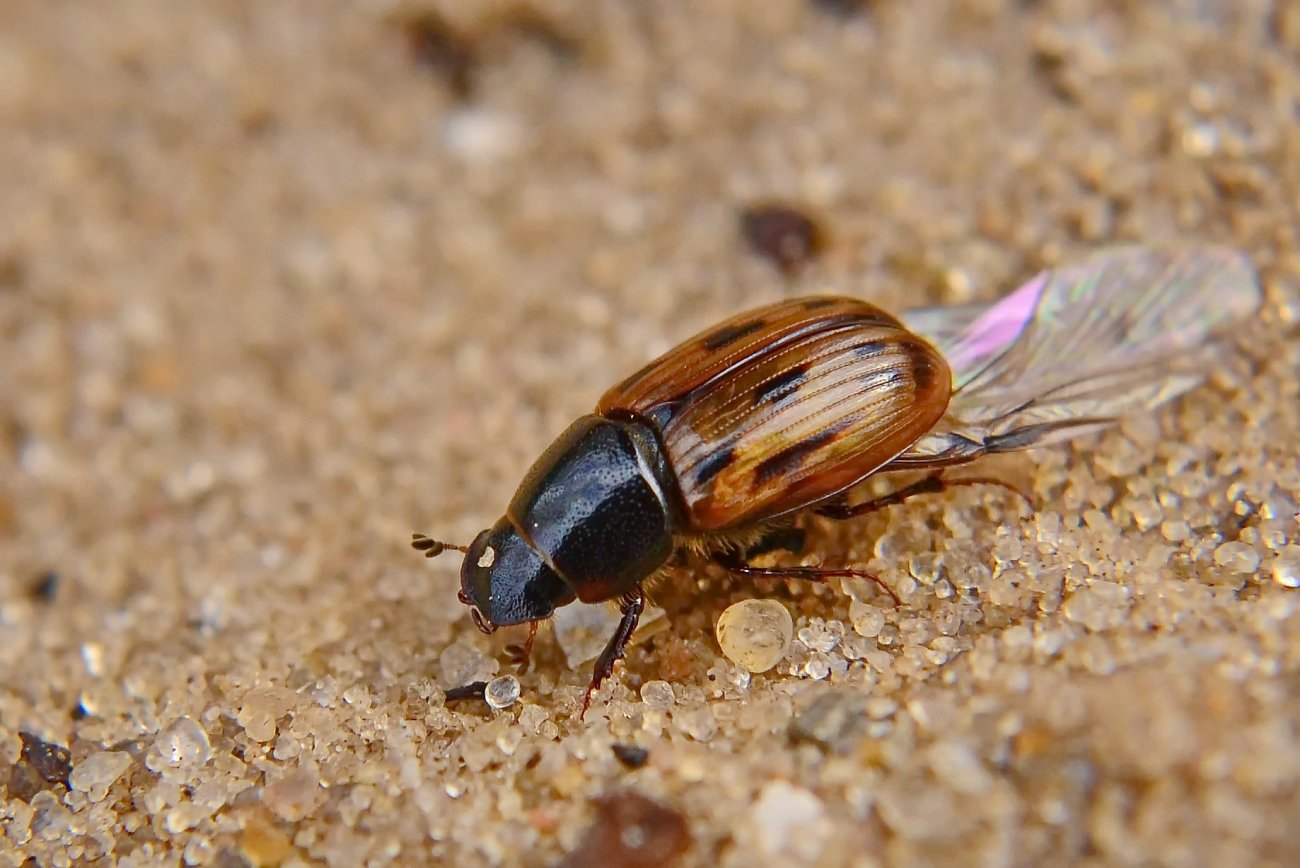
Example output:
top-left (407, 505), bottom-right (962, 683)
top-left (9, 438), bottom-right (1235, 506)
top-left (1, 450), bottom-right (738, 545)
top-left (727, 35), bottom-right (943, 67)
top-left (460, 518), bottom-right (573, 633)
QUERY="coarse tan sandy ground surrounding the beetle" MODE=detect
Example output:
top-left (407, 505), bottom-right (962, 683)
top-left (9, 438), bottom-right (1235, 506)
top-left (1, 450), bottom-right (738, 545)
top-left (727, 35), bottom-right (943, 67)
top-left (0, 0), bottom-right (1300, 868)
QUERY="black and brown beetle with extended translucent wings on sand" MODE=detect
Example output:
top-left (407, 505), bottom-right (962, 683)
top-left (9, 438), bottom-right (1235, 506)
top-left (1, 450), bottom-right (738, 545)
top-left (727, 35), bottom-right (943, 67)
top-left (412, 246), bottom-right (1261, 715)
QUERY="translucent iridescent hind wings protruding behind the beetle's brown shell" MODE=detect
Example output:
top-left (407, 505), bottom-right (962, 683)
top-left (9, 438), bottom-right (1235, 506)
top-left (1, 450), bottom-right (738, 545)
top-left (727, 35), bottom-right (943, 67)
top-left (887, 247), bottom-right (1261, 469)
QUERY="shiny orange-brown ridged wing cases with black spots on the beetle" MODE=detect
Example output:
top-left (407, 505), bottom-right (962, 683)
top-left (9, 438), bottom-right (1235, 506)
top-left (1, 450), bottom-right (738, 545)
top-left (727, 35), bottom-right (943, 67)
top-left (597, 296), bottom-right (952, 533)
